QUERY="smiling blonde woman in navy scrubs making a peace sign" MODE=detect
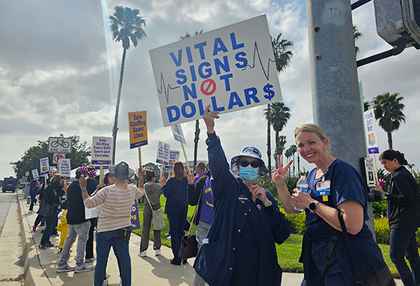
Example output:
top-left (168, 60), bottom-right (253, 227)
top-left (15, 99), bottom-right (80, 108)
top-left (272, 124), bottom-right (394, 286)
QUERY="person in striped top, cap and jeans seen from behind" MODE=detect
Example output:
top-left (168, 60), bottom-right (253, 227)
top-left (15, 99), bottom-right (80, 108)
top-left (79, 161), bottom-right (144, 286)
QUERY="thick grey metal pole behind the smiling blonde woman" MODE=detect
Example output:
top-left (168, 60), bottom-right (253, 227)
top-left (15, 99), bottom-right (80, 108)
top-left (307, 0), bottom-right (374, 237)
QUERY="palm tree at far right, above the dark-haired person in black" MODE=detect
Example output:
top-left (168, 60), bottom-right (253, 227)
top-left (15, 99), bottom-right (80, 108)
top-left (374, 92), bottom-right (405, 149)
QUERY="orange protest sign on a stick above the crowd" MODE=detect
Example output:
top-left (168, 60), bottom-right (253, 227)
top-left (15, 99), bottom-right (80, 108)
top-left (128, 111), bottom-right (147, 149)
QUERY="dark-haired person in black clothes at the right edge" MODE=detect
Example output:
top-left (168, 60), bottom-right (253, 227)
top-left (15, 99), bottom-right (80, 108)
top-left (379, 150), bottom-right (420, 286)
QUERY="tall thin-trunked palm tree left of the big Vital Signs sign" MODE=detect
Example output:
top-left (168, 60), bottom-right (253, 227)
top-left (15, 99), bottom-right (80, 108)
top-left (109, 6), bottom-right (146, 164)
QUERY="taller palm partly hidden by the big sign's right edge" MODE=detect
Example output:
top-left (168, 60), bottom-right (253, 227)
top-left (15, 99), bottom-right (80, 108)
top-left (264, 33), bottom-right (293, 174)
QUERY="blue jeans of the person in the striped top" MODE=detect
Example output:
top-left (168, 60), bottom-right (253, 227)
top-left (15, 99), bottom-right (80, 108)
top-left (94, 229), bottom-right (131, 286)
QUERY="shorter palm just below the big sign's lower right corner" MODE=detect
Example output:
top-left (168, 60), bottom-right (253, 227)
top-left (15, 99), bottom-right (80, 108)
top-left (266, 102), bottom-right (290, 166)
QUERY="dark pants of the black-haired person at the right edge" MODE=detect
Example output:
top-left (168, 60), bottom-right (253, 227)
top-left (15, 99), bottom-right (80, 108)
top-left (390, 228), bottom-right (420, 286)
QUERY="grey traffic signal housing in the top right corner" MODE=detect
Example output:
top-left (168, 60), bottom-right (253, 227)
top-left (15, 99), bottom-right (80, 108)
top-left (374, 0), bottom-right (420, 49)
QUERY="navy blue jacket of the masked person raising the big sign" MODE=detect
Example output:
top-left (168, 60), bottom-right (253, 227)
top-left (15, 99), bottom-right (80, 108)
top-left (194, 134), bottom-right (290, 286)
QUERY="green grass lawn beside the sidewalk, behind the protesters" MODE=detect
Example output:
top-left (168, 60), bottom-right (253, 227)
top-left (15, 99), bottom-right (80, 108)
top-left (134, 196), bottom-right (398, 277)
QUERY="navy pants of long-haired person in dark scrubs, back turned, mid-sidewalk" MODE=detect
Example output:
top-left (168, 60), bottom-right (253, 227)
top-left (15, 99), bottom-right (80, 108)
top-left (168, 213), bottom-right (186, 262)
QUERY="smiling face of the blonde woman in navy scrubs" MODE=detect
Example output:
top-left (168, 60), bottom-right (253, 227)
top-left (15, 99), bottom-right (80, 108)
top-left (296, 131), bottom-right (329, 165)
